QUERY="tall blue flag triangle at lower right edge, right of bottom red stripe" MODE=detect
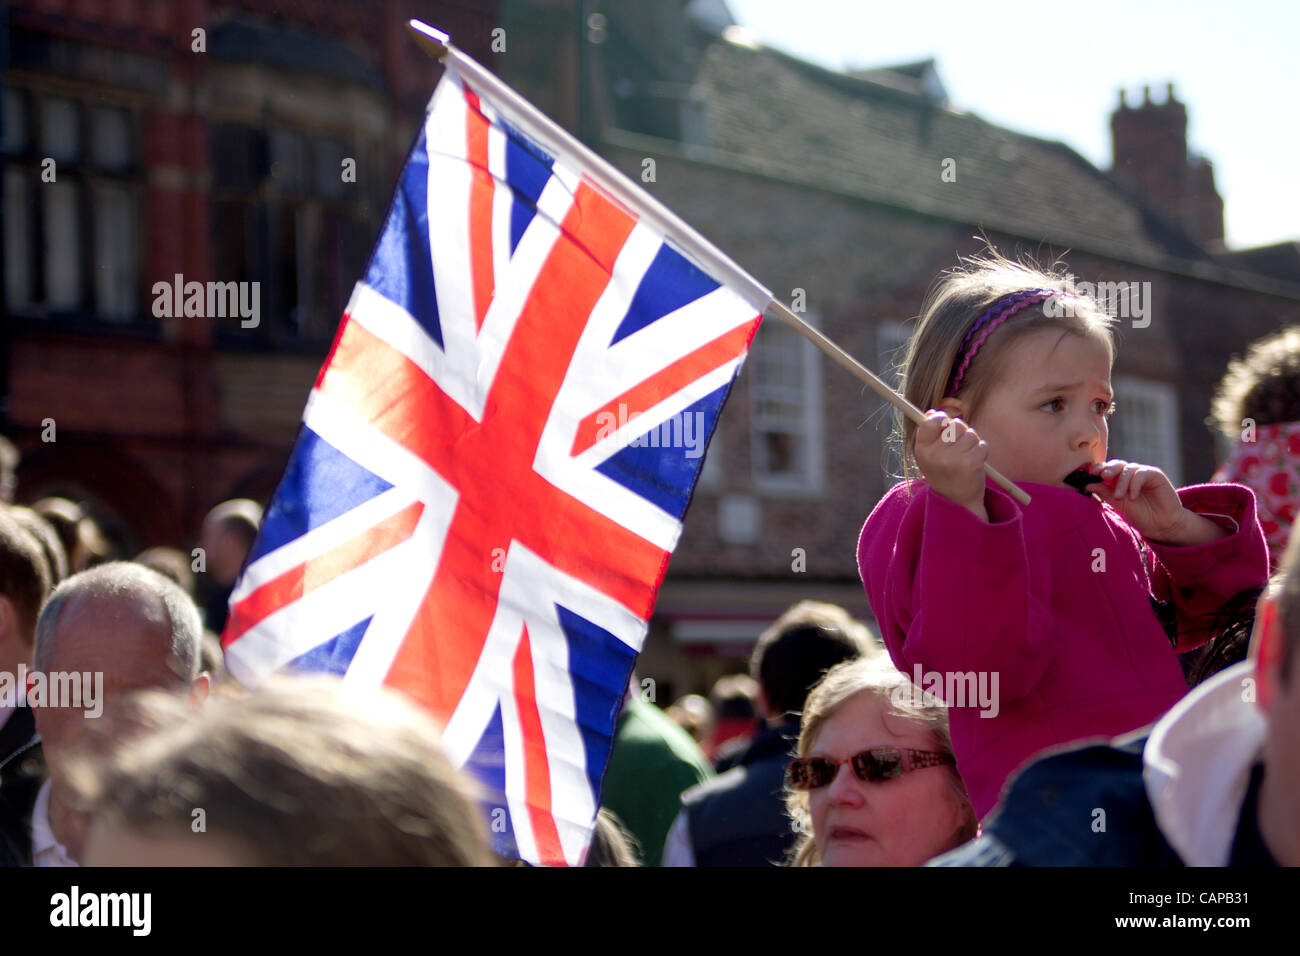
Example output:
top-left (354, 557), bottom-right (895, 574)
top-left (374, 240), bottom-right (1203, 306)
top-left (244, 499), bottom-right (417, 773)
top-left (555, 605), bottom-right (637, 793)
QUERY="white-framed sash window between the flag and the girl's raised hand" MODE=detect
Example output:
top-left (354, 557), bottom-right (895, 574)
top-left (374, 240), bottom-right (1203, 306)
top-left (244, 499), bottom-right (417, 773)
top-left (749, 315), bottom-right (823, 493)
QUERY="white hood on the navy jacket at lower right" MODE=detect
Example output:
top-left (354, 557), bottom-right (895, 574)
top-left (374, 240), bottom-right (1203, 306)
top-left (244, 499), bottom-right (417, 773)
top-left (1143, 661), bottom-right (1268, 866)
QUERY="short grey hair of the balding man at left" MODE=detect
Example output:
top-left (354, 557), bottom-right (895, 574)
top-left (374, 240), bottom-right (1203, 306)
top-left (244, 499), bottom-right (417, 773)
top-left (35, 561), bottom-right (203, 683)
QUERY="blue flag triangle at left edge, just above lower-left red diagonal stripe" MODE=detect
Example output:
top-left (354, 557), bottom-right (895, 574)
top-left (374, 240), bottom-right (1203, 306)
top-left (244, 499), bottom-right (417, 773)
top-left (247, 425), bottom-right (393, 564)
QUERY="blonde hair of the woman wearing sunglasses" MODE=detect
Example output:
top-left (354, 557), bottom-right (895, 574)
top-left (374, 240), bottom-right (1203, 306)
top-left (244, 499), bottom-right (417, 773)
top-left (785, 657), bottom-right (976, 866)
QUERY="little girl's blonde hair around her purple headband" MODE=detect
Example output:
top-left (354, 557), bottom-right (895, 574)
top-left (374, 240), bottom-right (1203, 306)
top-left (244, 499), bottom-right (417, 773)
top-left (893, 246), bottom-right (1115, 477)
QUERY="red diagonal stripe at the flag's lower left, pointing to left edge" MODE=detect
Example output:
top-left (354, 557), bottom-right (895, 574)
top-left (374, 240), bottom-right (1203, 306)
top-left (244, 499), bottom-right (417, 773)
top-left (222, 501), bottom-right (424, 645)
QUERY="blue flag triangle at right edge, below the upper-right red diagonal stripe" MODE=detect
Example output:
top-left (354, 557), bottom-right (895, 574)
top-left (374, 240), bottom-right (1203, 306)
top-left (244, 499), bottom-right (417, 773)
top-left (595, 384), bottom-right (731, 518)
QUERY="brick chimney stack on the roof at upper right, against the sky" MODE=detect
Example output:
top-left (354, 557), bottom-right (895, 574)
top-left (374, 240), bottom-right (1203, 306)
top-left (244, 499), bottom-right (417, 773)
top-left (1110, 83), bottom-right (1223, 248)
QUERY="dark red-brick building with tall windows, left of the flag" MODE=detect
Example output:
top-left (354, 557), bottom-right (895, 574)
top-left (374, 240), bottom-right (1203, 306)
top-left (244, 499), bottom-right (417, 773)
top-left (0, 0), bottom-right (499, 553)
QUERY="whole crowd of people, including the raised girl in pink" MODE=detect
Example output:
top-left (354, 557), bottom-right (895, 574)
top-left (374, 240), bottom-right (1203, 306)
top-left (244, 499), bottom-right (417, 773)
top-left (0, 255), bottom-right (1300, 866)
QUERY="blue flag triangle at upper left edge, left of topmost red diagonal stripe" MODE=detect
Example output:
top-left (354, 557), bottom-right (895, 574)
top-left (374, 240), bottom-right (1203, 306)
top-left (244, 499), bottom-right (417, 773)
top-left (364, 131), bottom-right (442, 346)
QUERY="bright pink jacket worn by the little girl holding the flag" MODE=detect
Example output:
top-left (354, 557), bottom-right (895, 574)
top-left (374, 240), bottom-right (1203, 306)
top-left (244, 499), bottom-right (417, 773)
top-left (858, 481), bottom-right (1269, 825)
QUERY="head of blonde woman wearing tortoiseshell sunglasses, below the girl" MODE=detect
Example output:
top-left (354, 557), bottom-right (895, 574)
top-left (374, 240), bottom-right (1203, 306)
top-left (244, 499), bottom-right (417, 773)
top-left (787, 659), bottom-right (975, 866)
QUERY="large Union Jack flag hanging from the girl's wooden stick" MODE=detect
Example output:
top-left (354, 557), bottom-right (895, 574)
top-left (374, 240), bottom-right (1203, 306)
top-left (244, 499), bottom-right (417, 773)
top-left (222, 48), bottom-right (766, 865)
